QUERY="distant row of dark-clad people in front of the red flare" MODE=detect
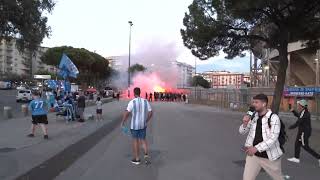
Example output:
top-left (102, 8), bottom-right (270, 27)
top-left (145, 92), bottom-right (187, 102)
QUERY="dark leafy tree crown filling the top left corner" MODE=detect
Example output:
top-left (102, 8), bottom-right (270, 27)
top-left (0, 0), bottom-right (55, 52)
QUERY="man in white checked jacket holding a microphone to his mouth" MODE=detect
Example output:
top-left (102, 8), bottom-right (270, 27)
top-left (239, 94), bottom-right (283, 180)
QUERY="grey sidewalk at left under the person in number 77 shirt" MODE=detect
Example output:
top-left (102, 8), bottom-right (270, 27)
top-left (0, 99), bottom-right (124, 180)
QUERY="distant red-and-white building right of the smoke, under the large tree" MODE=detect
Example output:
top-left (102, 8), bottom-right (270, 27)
top-left (199, 71), bottom-right (250, 88)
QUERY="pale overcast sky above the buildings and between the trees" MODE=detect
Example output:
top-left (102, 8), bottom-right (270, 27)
top-left (42, 0), bottom-right (249, 72)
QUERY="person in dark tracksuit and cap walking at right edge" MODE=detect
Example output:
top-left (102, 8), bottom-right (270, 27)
top-left (288, 99), bottom-right (320, 166)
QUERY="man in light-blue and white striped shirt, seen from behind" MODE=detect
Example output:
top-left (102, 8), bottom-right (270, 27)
top-left (121, 87), bottom-right (152, 165)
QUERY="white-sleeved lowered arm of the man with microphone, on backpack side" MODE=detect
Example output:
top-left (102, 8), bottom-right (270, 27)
top-left (255, 114), bottom-right (281, 152)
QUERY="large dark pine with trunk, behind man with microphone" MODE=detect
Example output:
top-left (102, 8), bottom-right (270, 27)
top-left (181, 0), bottom-right (320, 112)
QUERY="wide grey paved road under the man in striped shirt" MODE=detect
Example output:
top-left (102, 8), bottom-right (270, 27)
top-left (51, 103), bottom-right (320, 180)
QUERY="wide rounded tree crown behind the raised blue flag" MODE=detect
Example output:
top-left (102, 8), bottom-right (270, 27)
top-left (41, 46), bottom-right (111, 85)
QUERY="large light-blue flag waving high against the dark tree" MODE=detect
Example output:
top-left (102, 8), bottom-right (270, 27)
top-left (59, 53), bottom-right (79, 79)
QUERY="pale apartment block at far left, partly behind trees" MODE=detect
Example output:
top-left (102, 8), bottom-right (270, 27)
top-left (0, 40), bottom-right (56, 77)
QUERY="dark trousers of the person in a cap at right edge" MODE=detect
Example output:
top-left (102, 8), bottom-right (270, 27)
top-left (294, 133), bottom-right (320, 159)
